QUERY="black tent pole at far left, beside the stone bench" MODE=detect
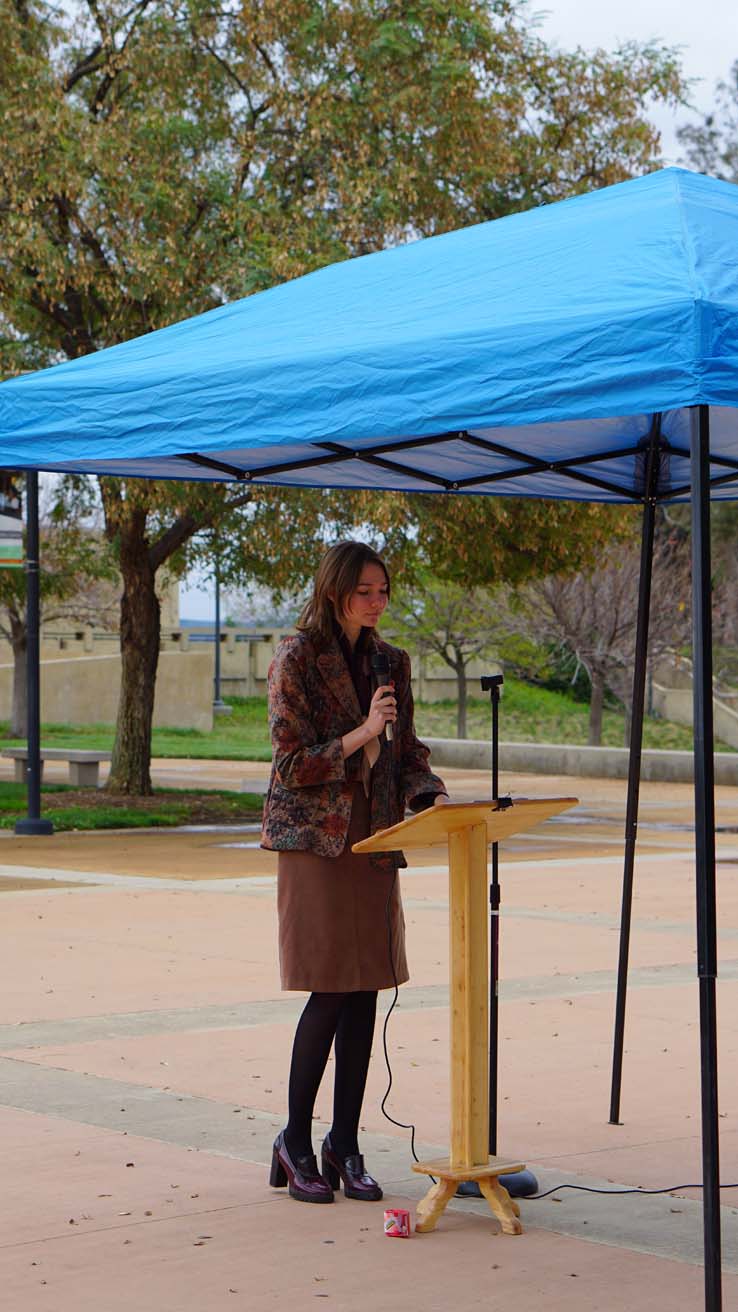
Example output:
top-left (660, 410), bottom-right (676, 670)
top-left (16, 470), bottom-right (54, 834)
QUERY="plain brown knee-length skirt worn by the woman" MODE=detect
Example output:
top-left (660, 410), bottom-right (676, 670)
top-left (277, 785), bottom-right (408, 993)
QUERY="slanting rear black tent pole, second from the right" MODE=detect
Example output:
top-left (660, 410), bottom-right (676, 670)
top-left (609, 416), bottom-right (661, 1126)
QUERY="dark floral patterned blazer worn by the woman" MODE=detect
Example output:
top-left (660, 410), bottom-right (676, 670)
top-left (261, 632), bottom-right (446, 867)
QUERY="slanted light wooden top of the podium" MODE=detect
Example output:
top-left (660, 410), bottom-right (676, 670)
top-left (351, 798), bottom-right (579, 851)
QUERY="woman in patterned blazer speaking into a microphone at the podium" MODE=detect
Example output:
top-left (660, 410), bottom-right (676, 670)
top-left (261, 542), bottom-right (448, 1203)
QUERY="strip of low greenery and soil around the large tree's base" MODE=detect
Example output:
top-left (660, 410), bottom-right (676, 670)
top-left (0, 781), bottom-right (261, 830)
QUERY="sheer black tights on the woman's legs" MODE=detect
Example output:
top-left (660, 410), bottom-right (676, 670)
top-left (285, 991), bottom-right (377, 1157)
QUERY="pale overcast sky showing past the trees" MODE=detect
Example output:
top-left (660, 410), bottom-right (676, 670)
top-left (180, 0), bottom-right (738, 619)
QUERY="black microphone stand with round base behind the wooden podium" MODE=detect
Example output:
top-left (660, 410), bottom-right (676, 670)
top-left (457, 674), bottom-right (538, 1198)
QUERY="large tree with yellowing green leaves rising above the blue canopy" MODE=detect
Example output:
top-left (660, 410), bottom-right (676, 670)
top-left (0, 0), bottom-right (683, 792)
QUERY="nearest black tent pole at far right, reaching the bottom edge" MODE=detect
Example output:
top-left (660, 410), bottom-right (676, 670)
top-left (691, 405), bottom-right (722, 1312)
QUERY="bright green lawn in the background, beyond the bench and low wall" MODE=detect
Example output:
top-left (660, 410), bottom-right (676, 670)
top-left (0, 678), bottom-right (731, 761)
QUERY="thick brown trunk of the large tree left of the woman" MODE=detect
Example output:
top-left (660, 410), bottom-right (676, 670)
top-left (105, 517), bottom-right (160, 796)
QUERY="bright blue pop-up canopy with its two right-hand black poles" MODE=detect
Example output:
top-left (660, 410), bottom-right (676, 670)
top-left (0, 169), bottom-right (738, 1309)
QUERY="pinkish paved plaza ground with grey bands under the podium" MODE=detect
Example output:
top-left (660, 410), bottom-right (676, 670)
top-left (0, 761), bottom-right (738, 1312)
